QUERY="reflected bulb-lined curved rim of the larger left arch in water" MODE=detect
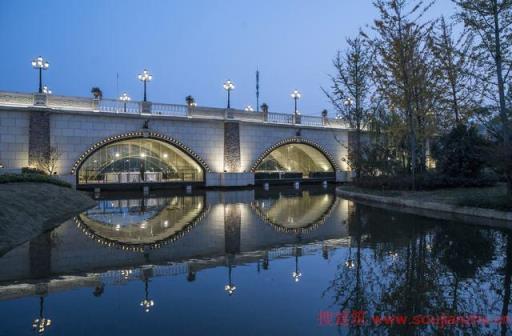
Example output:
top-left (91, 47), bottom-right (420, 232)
top-left (74, 206), bottom-right (210, 253)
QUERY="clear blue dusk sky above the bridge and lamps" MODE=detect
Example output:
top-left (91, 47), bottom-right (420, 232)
top-left (0, 0), bottom-right (454, 115)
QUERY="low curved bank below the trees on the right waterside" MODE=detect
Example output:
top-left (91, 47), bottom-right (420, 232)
top-left (336, 185), bottom-right (512, 221)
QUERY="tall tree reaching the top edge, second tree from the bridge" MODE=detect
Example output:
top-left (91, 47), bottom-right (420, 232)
top-left (371, 0), bottom-right (432, 189)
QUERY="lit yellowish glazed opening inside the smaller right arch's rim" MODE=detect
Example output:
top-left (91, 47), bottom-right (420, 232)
top-left (255, 143), bottom-right (334, 178)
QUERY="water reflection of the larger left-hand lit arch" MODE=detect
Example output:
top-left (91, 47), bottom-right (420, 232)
top-left (75, 196), bottom-right (208, 252)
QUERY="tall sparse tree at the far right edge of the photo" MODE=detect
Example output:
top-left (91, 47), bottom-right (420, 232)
top-left (452, 0), bottom-right (512, 197)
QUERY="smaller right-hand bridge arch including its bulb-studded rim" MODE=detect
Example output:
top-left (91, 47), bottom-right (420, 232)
top-left (251, 137), bottom-right (340, 177)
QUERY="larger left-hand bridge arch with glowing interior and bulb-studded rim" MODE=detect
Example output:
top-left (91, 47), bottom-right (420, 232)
top-left (71, 131), bottom-right (211, 185)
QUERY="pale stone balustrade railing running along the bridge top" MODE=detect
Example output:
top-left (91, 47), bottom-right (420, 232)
top-left (0, 91), bottom-right (350, 129)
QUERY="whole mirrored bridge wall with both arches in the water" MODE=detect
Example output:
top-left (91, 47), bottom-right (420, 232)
top-left (0, 187), bottom-right (349, 299)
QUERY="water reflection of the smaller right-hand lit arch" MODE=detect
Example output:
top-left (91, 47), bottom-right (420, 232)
top-left (252, 190), bottom-right (337, 233)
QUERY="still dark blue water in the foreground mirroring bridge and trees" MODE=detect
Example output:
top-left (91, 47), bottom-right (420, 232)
top-left (0, 187), bottom-right (512, 336)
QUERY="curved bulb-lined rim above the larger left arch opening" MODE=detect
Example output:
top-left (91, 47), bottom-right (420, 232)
top-left (71, 131), bottom-right (211, 175)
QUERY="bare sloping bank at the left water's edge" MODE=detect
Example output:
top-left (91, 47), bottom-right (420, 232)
top-left (0, 182), bottom-right (95, 256)
